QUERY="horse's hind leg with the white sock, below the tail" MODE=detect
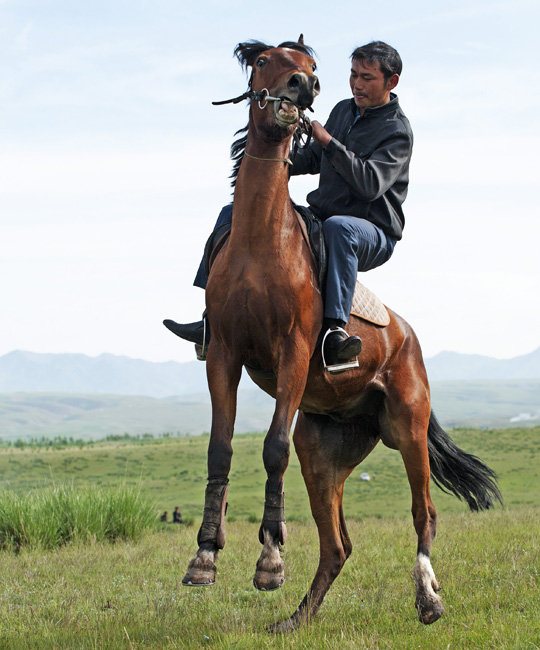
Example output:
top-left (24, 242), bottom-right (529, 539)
top-left (383, 375), bottom-right (444, 624)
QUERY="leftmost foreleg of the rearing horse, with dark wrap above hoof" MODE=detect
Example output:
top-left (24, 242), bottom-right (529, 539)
top-left (182, 343), bottom-right (242, 586)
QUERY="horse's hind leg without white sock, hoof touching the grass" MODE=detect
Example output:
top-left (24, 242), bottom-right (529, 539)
top-left (269, 413), bottom-right (379, 632)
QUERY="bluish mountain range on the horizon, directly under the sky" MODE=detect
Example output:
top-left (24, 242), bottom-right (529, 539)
top-left (0, 348), bottom-right (540, 397)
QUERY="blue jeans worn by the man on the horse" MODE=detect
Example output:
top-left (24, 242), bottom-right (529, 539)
top-left (193, 203), bottom-right (396, 322)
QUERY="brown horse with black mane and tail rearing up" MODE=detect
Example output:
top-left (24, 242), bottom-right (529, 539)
top-left (183, 41), bottom-right (500, 631)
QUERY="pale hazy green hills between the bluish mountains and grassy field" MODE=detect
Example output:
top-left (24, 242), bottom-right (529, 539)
top-left (0, 379), bottom-right (540, 440)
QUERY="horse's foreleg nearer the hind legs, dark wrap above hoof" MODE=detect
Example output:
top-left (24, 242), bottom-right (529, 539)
top-left (253, 345), bottom-right (309, 591)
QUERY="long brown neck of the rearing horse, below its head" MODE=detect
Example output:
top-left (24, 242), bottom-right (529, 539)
top-left (231, 134), bottom-right (294, 245)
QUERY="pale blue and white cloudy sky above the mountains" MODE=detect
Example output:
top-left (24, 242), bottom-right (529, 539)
top-left (0, 0), bottom-right (540, 361)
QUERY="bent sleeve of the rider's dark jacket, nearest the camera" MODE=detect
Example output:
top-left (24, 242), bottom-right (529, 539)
top-left (325, 132), bottom-right (412, 201)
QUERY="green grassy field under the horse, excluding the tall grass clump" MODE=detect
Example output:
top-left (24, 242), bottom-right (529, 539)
top-left (0, 428), bottom-right (540, 650)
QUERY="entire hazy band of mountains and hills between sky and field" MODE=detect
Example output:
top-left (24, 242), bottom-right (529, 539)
top-left (0, 349), bottom-right (540, 440)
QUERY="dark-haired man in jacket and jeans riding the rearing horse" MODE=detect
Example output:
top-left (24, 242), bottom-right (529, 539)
top-left (164, 41), bottom-right (413, 365)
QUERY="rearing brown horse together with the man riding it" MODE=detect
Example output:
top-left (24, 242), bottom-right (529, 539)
top-left (168, 37), bottom-right (500, 632)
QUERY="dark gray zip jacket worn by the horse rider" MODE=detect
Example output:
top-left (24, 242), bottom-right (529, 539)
top-left (291, 94), bottom-right (413, 240)
